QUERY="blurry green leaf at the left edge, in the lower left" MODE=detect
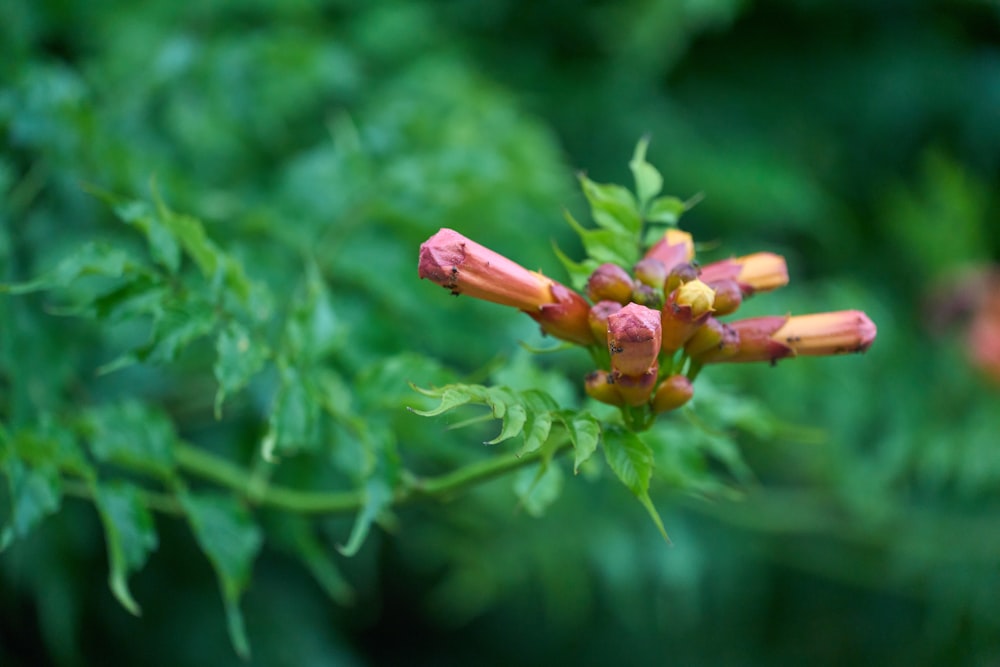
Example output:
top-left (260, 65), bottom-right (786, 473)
top-left (0, 454), bottom-right (62, 551)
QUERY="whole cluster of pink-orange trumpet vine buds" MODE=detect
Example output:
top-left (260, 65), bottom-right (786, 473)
top-left (418, 217), bottom-right (876, 429)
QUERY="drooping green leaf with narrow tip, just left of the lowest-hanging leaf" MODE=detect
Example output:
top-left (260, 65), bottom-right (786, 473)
top-left (92, 482), bottom-right (157, 616)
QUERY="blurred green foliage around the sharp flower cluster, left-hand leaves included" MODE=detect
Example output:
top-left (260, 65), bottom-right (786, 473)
top-left (0, 0), bottom-right (1000, 665)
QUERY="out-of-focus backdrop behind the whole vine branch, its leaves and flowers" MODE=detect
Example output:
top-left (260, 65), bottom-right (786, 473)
top-left (0, 0), bottom-right (1000, 665)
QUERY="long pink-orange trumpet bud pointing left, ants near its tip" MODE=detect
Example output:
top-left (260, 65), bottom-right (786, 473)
top-left (417, 229), bottom-right (595, 345)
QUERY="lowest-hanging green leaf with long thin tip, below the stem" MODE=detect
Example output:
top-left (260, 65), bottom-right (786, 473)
top-left (179, 492), bottom-right (263, 659)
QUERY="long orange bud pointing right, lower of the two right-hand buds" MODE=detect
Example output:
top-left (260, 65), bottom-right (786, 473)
top-left (704, 310), bottom-right (877, 361)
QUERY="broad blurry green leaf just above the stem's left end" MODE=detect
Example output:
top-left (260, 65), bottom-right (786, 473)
top-left (85, 401), bottom-right (177, 479)
